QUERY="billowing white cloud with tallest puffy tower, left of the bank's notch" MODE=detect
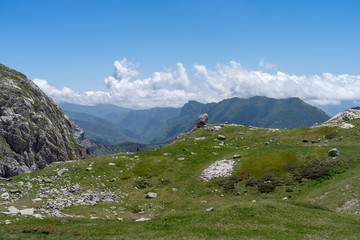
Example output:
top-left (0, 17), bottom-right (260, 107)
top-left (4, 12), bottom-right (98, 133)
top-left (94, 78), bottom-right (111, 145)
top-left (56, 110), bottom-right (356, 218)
top-left (104, 58), bottom-right (192, 108)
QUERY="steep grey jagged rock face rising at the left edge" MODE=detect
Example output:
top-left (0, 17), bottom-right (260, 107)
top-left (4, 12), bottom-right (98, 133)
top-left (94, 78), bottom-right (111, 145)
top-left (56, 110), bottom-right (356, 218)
top-left (0, 64), bottom-right (87, 177)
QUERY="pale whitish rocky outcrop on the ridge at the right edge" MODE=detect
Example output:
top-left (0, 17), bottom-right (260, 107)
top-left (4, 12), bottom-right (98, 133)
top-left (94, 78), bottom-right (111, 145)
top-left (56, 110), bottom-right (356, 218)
top-left (315, 108), bottom-right (360, 129)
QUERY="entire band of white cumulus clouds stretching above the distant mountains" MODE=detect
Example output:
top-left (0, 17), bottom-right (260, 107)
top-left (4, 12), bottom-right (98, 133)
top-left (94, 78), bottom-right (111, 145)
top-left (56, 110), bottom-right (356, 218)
top-left (34, 58), bottom-right (360, 108)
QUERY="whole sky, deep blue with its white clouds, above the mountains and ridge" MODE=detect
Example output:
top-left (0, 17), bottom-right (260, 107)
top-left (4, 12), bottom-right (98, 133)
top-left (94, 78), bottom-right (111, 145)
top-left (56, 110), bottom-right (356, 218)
top-left (0, 0), bottom-right (360, 115)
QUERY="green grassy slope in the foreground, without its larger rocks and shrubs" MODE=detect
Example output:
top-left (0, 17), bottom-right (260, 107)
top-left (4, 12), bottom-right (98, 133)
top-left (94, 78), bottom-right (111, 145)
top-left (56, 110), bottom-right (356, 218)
top-left (0, 120), bottom-right (360, 239)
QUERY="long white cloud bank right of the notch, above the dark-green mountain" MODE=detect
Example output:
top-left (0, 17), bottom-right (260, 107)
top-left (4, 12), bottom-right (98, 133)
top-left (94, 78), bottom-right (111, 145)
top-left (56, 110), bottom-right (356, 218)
top-left (195, 61), bottom-right (360, 105)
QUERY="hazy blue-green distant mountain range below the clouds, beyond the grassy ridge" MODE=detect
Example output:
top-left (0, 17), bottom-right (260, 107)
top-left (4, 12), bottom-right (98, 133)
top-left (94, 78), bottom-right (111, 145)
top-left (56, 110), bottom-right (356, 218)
top-left (60, 97), bottom-right (329, 145)
